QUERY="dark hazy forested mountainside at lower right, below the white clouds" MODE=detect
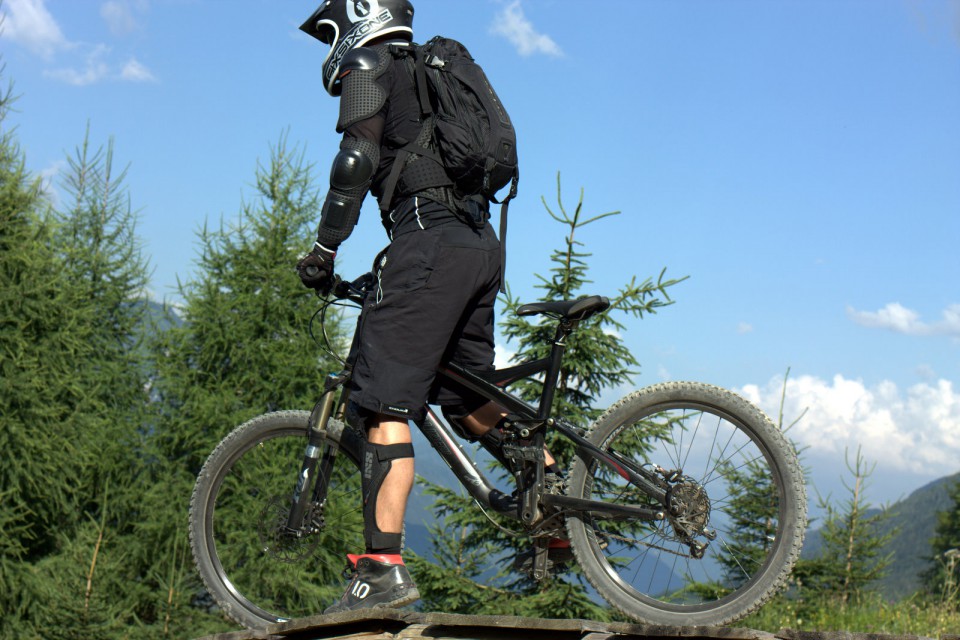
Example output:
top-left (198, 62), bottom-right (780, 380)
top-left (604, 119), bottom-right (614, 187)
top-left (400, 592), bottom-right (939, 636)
top-left (802, 473), bottom-right (960, 599)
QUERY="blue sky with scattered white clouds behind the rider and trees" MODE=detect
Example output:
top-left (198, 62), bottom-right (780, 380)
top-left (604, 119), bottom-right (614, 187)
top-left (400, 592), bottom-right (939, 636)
top-left (0, 0), bottom-right (960, 510)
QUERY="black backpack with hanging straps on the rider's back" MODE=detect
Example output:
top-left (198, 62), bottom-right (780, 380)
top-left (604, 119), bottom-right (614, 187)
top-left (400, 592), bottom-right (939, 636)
top-left (381, 36), bottom-right (520, 272)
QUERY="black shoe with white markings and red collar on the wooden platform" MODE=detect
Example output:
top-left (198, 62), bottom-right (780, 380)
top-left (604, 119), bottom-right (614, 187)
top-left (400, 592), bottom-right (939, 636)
top-left (324, 554), bottom-right (420, 613)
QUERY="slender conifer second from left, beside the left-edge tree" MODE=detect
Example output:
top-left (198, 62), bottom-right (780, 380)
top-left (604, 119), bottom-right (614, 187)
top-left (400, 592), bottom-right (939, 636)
top-left (24, 129), bottom-right (158, 637)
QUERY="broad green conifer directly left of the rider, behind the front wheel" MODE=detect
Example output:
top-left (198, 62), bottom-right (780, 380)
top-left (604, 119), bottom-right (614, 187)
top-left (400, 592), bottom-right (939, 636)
top-left (148, 139), bottom-right (340, 464)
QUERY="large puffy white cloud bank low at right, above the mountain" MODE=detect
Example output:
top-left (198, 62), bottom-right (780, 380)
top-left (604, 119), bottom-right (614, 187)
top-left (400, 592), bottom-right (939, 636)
top-left (740, 375), bottom-right (960, 477)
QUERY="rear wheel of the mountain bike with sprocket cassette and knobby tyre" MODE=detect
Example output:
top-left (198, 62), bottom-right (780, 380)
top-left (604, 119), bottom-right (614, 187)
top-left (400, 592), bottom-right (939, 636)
top-left (567, 382), bottom-right (806, 626)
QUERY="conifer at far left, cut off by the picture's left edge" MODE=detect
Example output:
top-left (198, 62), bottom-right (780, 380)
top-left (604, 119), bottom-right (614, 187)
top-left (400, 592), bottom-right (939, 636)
top-left (0, 71), bottom-right (99, 638)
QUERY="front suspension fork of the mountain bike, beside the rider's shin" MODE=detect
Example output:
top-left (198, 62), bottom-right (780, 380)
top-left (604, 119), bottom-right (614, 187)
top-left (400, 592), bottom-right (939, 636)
top-left (286, 374), bottom-right (338, 538)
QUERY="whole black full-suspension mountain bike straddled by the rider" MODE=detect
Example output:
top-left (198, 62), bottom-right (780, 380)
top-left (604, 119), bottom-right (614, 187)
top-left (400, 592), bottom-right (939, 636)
top-left (190, 274), bottom-right (806, 629)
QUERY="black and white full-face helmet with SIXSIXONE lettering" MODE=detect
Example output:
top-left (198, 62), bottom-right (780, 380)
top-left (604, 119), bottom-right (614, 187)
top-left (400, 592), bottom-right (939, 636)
top-left (300, 0), bottom-right (413, 96)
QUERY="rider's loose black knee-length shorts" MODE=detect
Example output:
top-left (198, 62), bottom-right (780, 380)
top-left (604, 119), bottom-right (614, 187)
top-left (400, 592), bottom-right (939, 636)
top-left (351, 221), bottom-right (500, 421)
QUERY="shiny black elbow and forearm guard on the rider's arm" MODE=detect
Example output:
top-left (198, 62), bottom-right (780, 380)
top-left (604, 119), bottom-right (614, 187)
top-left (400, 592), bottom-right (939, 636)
top-left (317, 138), bottom-right (380, 249)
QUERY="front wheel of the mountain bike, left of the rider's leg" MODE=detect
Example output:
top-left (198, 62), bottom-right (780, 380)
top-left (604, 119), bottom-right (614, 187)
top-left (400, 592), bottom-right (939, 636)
top-left (190, 411), bottom-right (363, 629)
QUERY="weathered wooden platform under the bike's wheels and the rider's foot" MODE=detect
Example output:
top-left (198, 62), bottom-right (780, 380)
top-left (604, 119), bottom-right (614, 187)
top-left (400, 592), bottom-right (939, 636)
top-left (198, 609), bottom-right (944, 640)
